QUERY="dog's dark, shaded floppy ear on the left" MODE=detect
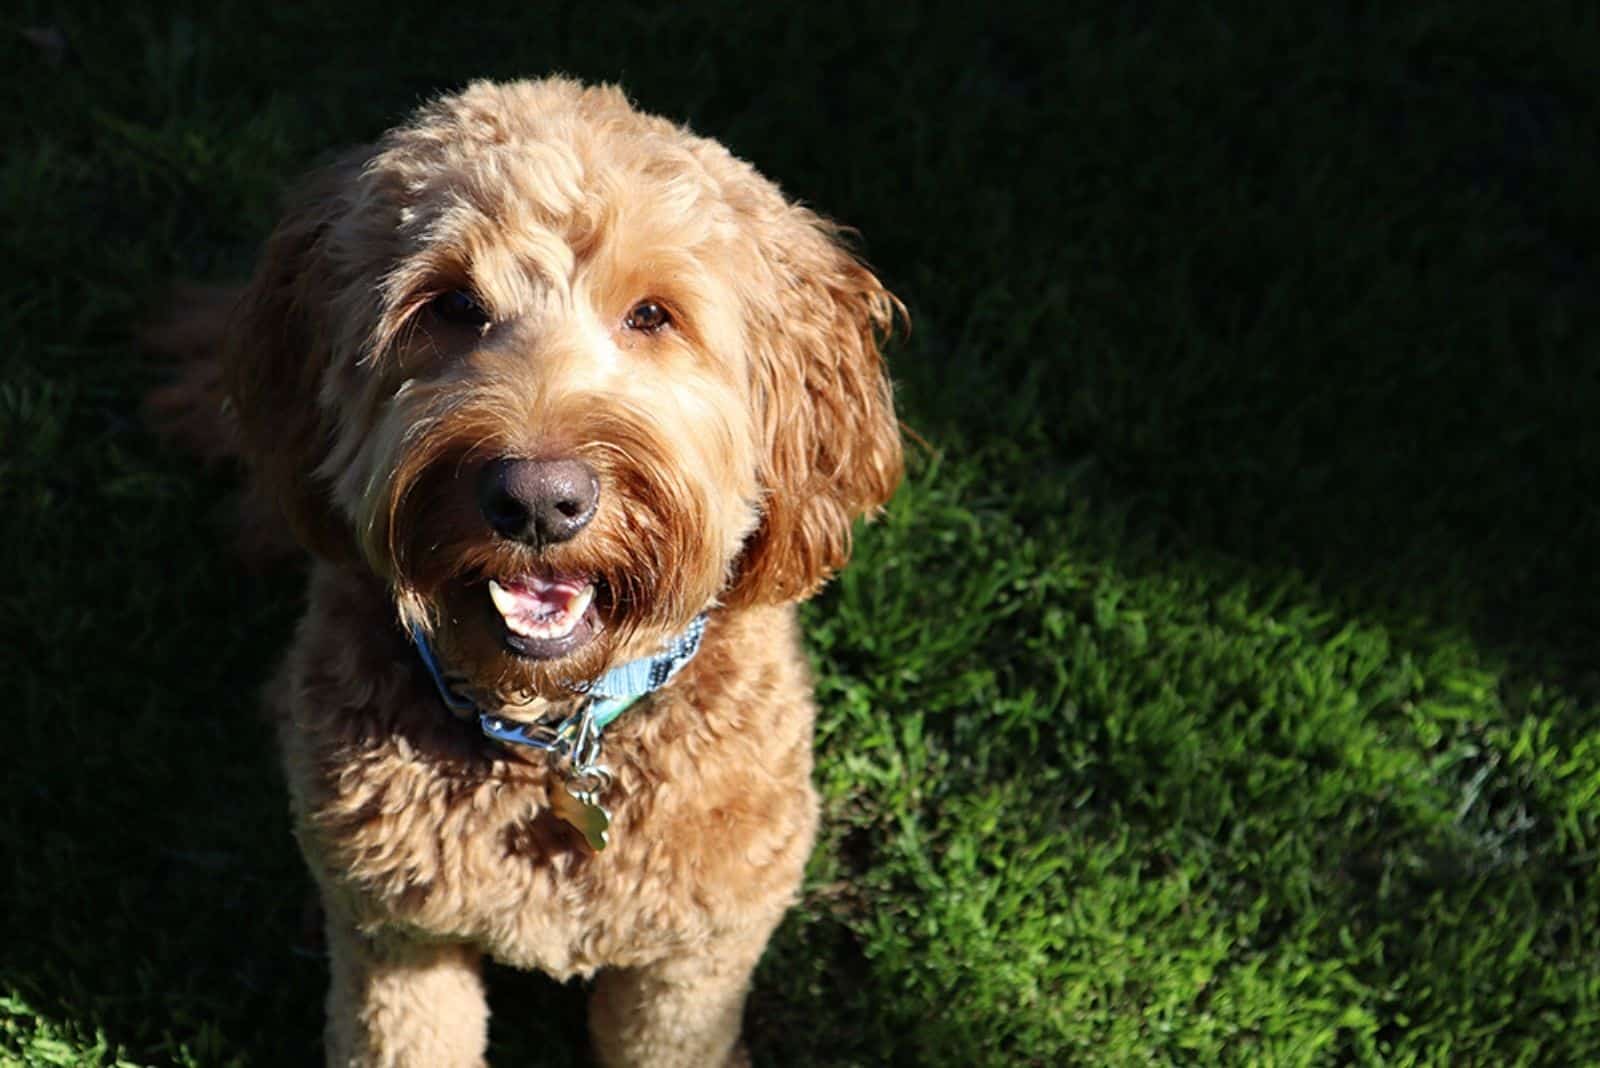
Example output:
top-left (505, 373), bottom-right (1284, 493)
top-left (222, 158), bottom-right (366, 560)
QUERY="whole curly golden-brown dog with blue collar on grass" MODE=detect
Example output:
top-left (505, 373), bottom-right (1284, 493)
top-left (157, 78), bottom-right (904, 1068)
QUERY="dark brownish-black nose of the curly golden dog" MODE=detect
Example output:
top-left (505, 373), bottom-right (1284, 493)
top-left (478, 459), bottom-right (600, 547)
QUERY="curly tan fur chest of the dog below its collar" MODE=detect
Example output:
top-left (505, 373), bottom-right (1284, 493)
top-left (280, 668), bottom-right (816, 977)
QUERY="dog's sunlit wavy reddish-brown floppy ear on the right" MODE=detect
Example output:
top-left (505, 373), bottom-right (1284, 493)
top-left (725, 205), bottom-right (904, 604)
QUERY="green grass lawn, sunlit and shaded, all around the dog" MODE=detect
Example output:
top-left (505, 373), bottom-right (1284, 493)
top-left (0, 0), bottom-right (1600, 1066)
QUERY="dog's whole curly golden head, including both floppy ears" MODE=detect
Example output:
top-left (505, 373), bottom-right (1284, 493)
top-left (227, 80), bottom-right (901, 699)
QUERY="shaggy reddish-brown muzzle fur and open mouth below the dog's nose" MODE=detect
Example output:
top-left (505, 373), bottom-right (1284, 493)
top-left (370, 412), bottom-right (754, 705)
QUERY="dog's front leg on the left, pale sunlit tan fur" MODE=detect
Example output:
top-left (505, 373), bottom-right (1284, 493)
top-left (326, 910), bottom-right (488, 1068)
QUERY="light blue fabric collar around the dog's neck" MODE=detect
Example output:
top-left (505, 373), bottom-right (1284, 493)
top-left (411, 612), bottom-right (706, 772)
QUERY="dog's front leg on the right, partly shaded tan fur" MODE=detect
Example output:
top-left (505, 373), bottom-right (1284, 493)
top-left (589, 924), bottom-right (776, 1068)
